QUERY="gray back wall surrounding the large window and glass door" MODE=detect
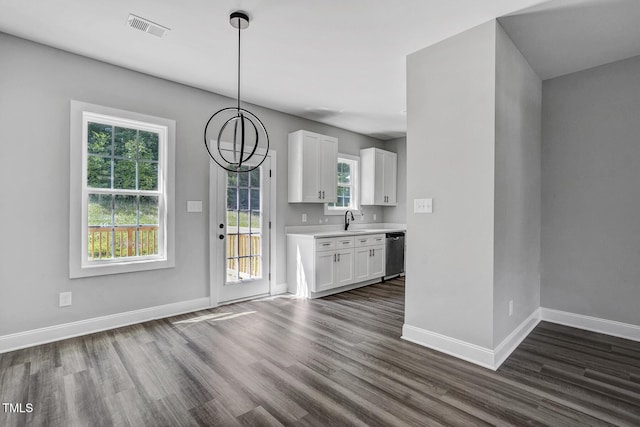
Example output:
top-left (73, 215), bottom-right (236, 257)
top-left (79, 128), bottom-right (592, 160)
top-left (0, 33), bottom-right (384, 335)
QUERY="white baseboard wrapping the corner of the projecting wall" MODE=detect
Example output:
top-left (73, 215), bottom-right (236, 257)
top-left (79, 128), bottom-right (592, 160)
top-left (402, 309), bottom-right (540, 371)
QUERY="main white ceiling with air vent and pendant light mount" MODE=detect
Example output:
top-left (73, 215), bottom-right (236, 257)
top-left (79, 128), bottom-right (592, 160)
top-left (0, 0), bottom-right (552, 139)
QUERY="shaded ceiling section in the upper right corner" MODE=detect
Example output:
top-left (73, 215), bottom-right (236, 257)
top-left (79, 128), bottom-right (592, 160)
top-left (499, 0), bottom-right (640, 80)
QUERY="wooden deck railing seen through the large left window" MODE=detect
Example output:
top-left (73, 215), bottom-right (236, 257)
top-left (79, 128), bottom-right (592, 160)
top-left (87, 225), bottom-right (158, 260)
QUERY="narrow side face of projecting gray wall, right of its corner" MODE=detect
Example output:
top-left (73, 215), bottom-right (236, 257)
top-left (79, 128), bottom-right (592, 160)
top-left (493, 24), bottom-right (542, 347)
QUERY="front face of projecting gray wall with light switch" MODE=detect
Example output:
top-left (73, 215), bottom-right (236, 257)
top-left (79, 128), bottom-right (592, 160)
top-left (405, 21), bottom-right (496, 347)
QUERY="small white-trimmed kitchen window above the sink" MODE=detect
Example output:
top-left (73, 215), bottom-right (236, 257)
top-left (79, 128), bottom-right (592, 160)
top-left (324, 154), bottom-right (360, 215)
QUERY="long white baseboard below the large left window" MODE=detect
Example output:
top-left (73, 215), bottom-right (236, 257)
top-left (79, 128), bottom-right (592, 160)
top-left (0, 297), bottom-right (210, 354)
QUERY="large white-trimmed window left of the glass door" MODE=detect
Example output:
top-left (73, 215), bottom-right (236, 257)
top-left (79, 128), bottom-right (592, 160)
top-left (69, 101), bottom-right (175, 277)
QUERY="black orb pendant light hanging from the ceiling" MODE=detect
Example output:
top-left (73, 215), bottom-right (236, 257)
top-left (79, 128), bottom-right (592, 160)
top-left (204, 11), bottom-right (269, 172)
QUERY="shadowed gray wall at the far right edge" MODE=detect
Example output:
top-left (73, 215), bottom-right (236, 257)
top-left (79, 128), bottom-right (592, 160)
top-left (541, 57), bottom-right (640, 325)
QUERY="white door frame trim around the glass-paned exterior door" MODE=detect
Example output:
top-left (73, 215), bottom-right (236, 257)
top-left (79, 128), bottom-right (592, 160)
top-left (208, 144), bottom-right (278, 307)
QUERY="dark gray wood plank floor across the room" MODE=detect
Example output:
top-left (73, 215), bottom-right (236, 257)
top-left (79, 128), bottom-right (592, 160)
top-left (0, 280), bottom-right (640, 426)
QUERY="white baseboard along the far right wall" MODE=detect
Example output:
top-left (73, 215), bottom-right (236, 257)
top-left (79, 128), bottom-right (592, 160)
top-left (540, 307), bottom-right (640, 341)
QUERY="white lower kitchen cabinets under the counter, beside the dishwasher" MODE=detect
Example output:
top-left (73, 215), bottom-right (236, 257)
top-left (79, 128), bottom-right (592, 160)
top-left (287, 234), bottom-right (385, 296)
